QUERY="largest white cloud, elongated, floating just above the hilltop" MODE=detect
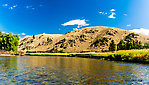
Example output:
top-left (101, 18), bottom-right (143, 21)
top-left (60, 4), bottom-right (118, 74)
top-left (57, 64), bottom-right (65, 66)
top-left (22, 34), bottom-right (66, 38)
top-left (62, 19), bottom-right (89, 28)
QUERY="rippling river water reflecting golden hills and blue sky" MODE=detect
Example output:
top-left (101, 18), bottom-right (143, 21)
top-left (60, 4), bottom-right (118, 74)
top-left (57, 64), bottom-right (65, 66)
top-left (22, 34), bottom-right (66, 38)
top-left (0, 56), bottom-right (149, 84)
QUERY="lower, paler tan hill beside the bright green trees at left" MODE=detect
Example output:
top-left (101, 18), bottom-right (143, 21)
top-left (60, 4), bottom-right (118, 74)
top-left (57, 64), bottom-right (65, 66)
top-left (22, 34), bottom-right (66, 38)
top-left (18, 34), bottom-right (61, 51)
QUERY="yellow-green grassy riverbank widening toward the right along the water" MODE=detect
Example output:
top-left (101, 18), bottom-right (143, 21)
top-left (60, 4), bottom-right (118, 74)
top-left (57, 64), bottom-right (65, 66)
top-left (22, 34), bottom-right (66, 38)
top-left (26, 49), bottom-right (149, 63)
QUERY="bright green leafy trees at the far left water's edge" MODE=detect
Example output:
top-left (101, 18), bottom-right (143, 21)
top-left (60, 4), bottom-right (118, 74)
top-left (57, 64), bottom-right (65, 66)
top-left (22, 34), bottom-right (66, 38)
top-left (0, 31), bottom-right (19, 52)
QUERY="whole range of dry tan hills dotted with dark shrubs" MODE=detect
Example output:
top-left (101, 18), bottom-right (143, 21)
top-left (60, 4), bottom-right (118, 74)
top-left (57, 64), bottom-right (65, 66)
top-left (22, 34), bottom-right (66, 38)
top-left (19, 27), bottom-right (149, 52)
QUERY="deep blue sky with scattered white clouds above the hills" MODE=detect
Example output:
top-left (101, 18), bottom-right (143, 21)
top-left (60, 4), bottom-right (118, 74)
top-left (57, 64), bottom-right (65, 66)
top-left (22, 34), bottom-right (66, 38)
top-left (0, 0), bottom-right (149, 37)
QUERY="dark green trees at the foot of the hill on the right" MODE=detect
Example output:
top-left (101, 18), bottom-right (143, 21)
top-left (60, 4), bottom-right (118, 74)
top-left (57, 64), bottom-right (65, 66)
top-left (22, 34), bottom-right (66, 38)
top-left (109, 39), bottom-right (144, 51)
